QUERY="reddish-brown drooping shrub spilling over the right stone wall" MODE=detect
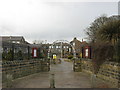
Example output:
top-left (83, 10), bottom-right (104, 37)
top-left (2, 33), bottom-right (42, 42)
top-left (92, 43), bottom-right (114, 74)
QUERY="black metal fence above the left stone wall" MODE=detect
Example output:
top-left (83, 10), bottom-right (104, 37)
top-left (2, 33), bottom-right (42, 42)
top-left (2, 42), bottom-right (46, 61)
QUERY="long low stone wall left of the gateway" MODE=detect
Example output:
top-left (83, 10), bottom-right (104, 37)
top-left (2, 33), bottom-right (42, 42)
top-left (2, 60), bottom-right (50, 82)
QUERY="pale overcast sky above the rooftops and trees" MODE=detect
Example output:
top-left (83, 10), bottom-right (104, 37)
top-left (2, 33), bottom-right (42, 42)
top-left (0, 0), bottom-right (118, 42)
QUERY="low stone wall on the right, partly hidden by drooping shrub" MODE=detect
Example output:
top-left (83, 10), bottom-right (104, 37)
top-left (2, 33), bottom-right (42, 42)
top-left (82, 60), bottom-right (120, 87)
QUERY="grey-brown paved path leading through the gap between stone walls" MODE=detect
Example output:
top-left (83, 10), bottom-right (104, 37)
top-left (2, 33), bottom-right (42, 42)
top-left (14, 61), bottom-right (91, 88)
